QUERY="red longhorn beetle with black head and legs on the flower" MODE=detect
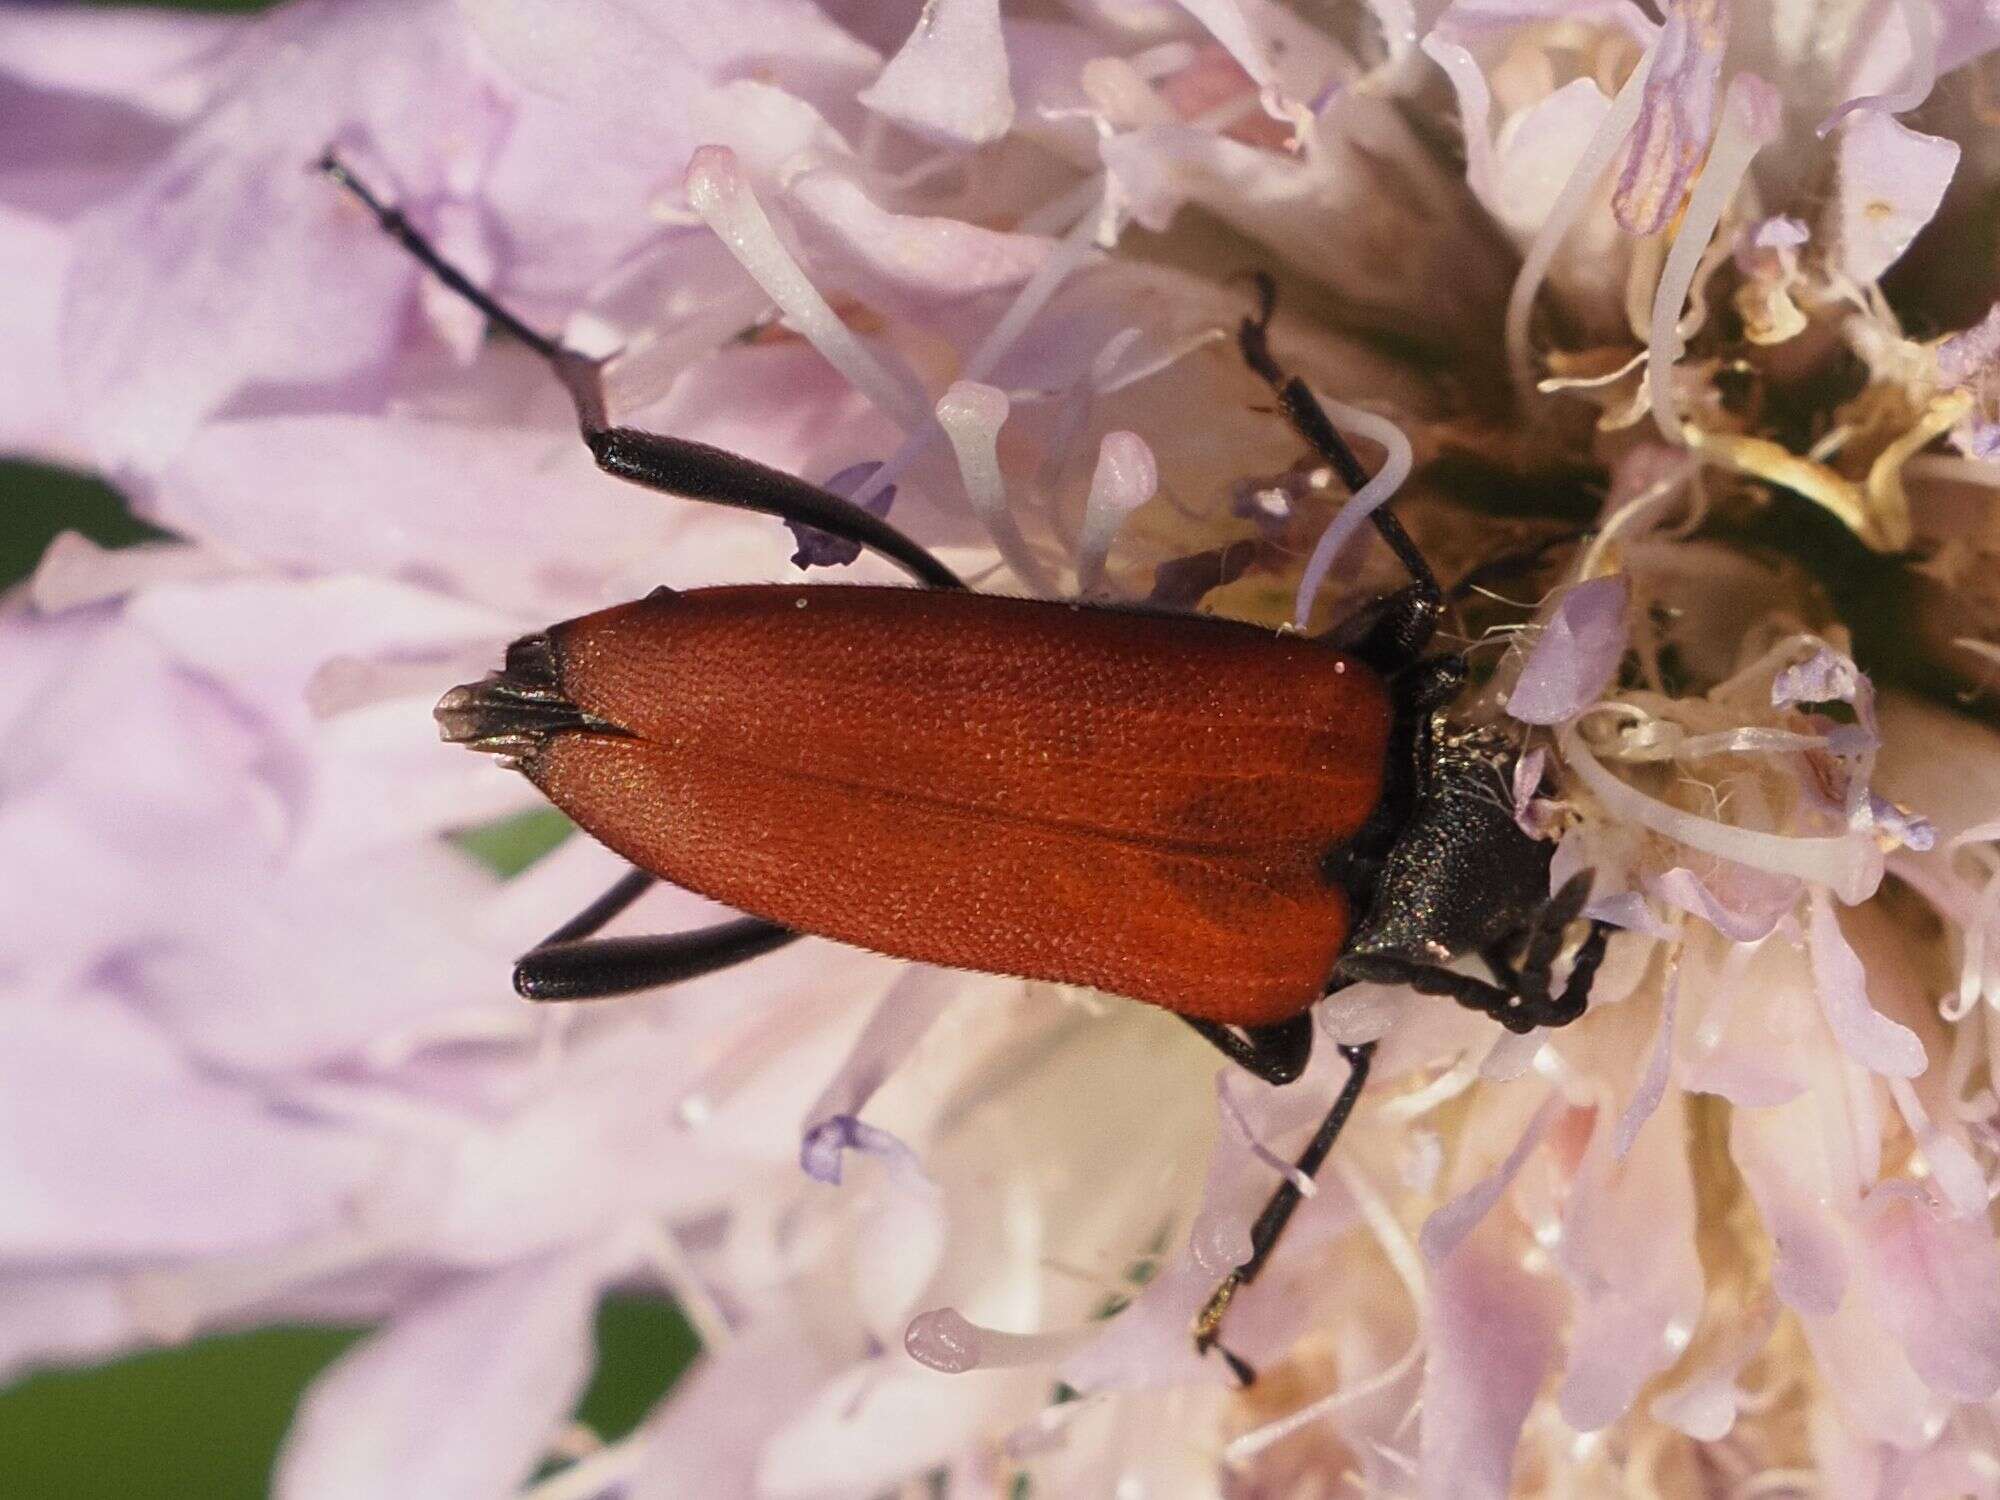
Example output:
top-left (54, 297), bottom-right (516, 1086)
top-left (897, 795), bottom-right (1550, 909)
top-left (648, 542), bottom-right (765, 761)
top-left (320, 154), bottom-right (1606, 1382)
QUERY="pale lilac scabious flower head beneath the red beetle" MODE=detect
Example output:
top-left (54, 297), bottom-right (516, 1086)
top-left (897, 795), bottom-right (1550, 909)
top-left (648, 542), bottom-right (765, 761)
top-left (11, 0), bottom-right (2000, 1500)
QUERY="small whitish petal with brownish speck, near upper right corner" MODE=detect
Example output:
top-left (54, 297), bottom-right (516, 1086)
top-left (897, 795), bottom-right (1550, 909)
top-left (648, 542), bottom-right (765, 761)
top-left (1834, 110), bottom-right (1958, 286)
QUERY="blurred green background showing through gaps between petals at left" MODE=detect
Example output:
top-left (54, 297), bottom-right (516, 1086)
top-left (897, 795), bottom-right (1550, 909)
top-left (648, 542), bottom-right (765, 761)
top-left (0, 0), bottom-right (696, 1500)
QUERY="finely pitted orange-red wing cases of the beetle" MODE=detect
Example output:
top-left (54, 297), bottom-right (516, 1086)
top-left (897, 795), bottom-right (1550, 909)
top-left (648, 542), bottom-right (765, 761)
top-left (446, 586), bottom-right (1394, 1026)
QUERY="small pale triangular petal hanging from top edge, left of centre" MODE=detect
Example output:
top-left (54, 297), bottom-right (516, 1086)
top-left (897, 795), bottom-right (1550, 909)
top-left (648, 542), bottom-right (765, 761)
top-left (858, 0), bottom-right (1014, 146)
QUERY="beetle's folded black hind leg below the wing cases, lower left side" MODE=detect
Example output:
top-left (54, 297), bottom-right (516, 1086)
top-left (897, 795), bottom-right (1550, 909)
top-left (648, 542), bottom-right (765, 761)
top-left (514, 870), bottom-right (798, 1000)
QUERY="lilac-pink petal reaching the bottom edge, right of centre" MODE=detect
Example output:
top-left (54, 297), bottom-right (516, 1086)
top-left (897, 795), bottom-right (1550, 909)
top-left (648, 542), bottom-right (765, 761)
top-left (1418, 1234), bottom-right (1562, 1500)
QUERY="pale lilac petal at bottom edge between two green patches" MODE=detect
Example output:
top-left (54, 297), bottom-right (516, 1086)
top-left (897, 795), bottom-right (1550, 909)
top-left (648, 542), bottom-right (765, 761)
top-left (272, 1250), bottom-right (614, 1500)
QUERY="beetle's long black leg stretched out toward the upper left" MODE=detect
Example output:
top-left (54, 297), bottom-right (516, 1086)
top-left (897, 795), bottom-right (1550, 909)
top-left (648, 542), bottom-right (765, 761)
top-left (318, 152), bottom-right (964, 588)
